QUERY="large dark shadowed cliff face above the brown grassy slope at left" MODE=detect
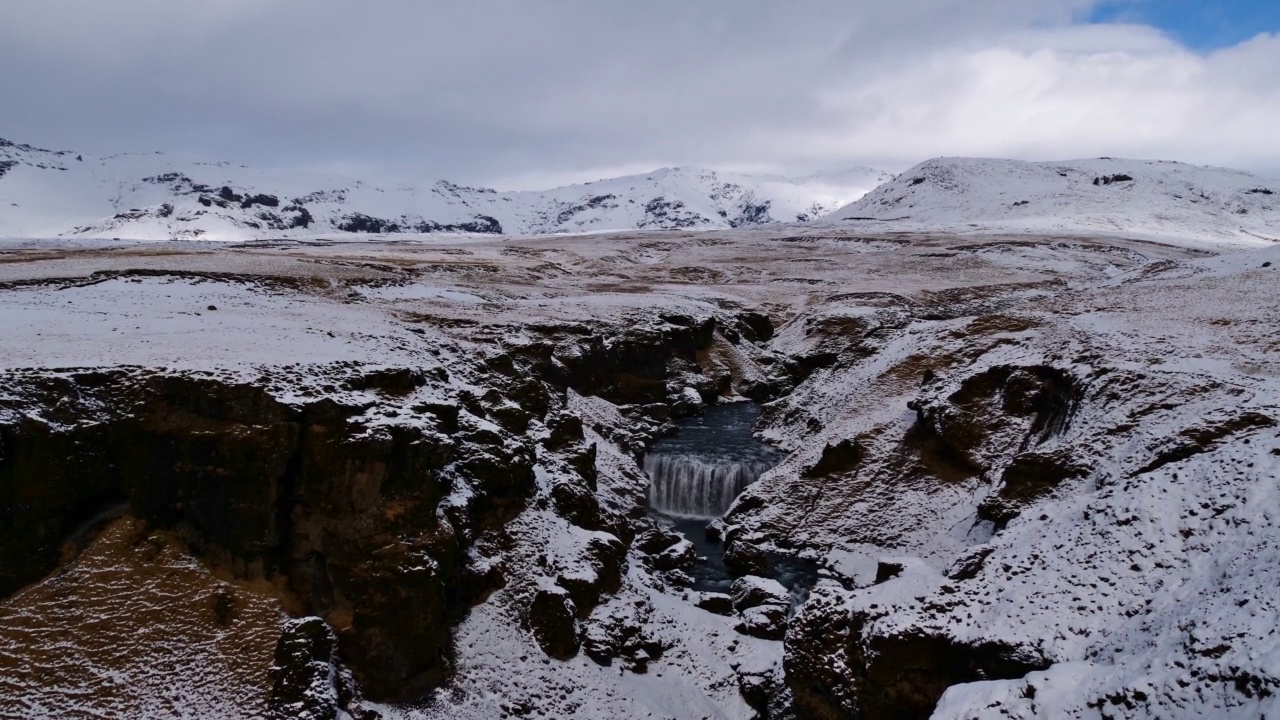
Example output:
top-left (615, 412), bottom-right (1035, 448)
top-left (0, 370), bottom-right (534, 700)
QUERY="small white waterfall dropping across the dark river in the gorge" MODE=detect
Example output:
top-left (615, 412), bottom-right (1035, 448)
top-left (644, 452), bottom-right (777, 518)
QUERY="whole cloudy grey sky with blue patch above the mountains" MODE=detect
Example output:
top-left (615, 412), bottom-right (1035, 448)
top-left (0, 0), bottom-right (1280, 188)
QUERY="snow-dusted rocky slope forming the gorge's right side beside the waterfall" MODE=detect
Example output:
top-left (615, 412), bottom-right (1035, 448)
top-left (726, 239), bottom-right (1280, 717)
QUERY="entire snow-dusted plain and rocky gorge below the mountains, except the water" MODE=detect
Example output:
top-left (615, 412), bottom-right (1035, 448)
top-left (0, 229), bottom-right (1280, 719)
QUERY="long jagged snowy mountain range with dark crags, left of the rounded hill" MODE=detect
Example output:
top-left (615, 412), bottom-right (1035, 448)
top-left (0, 140), bottom-right (891, 240)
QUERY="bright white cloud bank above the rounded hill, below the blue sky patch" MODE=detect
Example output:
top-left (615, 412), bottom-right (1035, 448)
top-left (799, 27), bottom-right (1280, 170)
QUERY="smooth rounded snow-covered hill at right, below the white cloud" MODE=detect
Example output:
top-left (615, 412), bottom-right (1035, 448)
top-left (824, 158), bottom-right (1280, 245)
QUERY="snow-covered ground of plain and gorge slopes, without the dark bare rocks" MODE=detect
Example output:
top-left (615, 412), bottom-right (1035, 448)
top-left (0, 229), bottom-right (1280, 719)
